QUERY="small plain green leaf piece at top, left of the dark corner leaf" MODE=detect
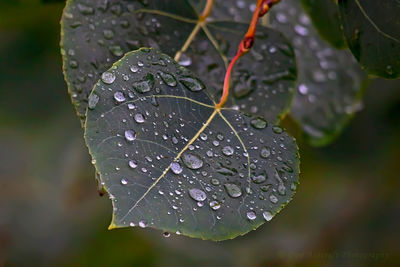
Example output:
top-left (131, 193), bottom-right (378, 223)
top-left (301, 0), bottom-right (347, 48)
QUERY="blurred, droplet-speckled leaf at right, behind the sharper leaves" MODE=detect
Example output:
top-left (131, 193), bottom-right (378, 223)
top-left (270, 0), bottom-right (366, 145)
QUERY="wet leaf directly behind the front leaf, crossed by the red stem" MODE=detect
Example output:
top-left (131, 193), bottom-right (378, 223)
top-left (61, 0), bottom-right (296, 122)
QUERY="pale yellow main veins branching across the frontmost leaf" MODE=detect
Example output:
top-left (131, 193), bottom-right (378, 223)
top-left (115, 95), bottom-right (251, 223)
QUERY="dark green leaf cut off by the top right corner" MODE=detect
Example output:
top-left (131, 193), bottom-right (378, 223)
top-left (339, 0), bottom-right (400, 79)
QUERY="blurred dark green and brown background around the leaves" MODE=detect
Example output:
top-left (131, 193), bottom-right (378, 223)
top-left (0, 0), bottom-right (400, 266)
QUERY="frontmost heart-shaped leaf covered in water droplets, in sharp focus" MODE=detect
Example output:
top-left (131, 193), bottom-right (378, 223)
top-left (85, 48), bottom-right (299, 240)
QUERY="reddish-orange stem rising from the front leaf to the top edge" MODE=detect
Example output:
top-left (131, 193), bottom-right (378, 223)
top-left (215, 0), bottom-right (280, 108)
